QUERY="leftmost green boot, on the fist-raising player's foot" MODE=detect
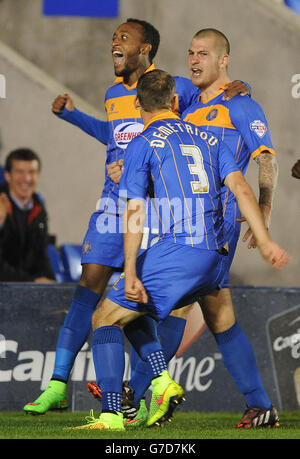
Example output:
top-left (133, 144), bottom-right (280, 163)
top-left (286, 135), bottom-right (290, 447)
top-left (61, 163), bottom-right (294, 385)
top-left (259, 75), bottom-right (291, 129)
top-left (24, 381), bottom-right (69, 414)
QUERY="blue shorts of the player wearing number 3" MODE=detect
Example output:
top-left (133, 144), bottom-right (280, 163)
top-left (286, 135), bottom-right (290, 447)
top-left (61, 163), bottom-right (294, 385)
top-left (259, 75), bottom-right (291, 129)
top-left (107, 238), bottom-right (227, 319)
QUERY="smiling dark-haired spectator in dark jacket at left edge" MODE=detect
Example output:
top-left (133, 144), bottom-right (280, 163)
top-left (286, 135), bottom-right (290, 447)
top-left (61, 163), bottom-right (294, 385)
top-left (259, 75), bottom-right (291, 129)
top-left (0, 148), bottom-right (54, 282)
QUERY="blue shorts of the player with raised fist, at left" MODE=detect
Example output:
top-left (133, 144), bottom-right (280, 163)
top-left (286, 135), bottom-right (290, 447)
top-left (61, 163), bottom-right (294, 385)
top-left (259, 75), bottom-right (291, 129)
top-left (81, 211), bottom-right (158, 269)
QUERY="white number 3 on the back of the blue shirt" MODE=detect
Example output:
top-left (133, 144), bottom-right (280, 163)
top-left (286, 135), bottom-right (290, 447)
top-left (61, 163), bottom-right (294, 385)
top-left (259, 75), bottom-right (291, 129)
top-left (180, 145), bottom-right (209, 194)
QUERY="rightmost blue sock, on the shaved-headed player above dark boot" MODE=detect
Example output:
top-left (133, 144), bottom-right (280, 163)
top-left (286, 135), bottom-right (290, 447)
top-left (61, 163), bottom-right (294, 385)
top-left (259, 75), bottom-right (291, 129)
top-left (215, 322), bottom-right (271, 409)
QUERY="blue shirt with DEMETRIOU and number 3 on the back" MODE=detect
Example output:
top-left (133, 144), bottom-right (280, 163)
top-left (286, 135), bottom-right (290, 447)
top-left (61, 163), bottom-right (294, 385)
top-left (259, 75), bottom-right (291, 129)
top-left (120, 112), bottom-right (239, 250)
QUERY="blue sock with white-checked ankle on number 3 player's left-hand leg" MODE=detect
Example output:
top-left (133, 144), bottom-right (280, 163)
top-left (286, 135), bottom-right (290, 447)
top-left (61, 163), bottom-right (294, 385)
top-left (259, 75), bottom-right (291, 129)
top-left (92, 326), bottom-right (125, 412)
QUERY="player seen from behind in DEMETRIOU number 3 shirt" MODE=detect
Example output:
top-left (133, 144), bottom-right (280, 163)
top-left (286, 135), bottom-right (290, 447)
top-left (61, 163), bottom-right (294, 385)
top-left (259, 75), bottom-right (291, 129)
top-left (66, 70), bottom-right (290, 430)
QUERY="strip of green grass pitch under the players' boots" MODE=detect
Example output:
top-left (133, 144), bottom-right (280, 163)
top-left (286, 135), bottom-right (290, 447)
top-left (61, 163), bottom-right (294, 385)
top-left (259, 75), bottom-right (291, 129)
top-left (0, 411), bottom-right (300, 442)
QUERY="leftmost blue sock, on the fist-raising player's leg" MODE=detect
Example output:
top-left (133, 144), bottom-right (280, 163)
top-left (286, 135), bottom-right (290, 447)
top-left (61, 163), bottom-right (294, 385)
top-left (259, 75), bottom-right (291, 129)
top-left (52, 285), bottom-right (101, 382)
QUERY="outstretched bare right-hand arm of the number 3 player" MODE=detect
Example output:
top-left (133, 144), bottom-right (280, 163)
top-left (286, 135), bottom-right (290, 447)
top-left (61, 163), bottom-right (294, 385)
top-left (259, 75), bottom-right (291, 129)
top-left (225, 172), bottom-right (291, 269)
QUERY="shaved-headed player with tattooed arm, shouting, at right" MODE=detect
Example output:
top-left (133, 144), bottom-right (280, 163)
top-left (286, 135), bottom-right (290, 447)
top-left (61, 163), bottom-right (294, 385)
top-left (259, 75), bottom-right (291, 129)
top-left (182, 29), bottom-right (278, 428)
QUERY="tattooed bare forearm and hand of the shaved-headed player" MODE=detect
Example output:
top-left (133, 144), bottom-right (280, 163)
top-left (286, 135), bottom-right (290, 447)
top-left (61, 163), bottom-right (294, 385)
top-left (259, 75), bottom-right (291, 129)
top-left (242, 150), bottom-right (278, 249)
